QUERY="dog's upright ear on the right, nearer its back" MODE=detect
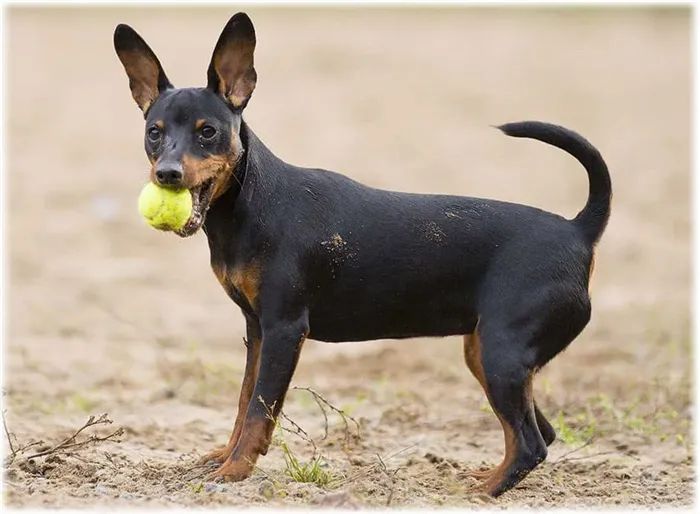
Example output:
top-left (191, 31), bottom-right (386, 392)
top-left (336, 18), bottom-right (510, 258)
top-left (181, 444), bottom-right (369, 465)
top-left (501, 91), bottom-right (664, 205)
top-left (207, 12), bottom-right (258, 108)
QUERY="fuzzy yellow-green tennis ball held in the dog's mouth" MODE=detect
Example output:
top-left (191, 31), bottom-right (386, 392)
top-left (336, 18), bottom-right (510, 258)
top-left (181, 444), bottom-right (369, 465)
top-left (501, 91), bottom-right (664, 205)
top-left (139, 182), bottom-right (192, 230)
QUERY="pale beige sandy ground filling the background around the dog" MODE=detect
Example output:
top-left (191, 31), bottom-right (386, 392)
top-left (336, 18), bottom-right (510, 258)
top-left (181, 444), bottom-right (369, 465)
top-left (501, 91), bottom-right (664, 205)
top-left (3, 8), bottom-right (694, 507)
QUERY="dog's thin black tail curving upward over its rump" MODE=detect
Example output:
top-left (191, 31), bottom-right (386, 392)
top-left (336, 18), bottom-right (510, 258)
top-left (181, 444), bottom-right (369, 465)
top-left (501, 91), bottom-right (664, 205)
top-left (496, 121), bottom-right (612, 245)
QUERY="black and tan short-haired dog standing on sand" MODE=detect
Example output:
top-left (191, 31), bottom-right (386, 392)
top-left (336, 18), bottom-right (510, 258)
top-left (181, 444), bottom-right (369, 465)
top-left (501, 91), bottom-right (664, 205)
top-left (114, 13), bottom-right (612, 496)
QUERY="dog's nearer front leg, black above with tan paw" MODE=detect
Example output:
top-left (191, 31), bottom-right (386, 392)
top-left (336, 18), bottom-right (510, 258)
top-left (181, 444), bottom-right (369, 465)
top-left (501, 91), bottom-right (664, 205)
top-left (211, 315), bottom-right (309, 482)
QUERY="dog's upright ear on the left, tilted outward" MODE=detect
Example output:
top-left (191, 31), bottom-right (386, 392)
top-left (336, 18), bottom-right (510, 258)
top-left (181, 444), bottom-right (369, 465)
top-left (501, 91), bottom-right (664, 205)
top-left (114, 24), bottom-right (173, 114)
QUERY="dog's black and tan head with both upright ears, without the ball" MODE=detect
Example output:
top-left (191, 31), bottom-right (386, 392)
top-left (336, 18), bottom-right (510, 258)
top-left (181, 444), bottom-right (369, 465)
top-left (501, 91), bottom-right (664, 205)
top-left (114, 13), bottom-right (257, 237)
